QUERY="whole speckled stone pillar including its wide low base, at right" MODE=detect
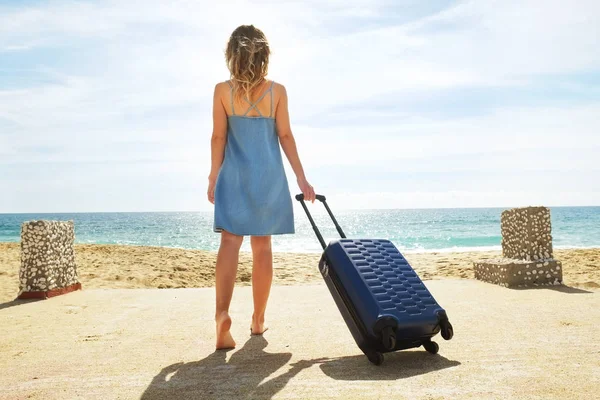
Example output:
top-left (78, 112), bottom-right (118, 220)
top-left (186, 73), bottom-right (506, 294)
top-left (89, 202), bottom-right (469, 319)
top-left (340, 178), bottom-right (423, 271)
top-left (473, 207), bottom-right (562, 287)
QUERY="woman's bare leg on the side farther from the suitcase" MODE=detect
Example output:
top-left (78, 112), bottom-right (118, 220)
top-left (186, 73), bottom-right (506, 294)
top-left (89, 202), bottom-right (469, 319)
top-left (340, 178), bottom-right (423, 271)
top-left (215, 232), bottom-right (244, 349)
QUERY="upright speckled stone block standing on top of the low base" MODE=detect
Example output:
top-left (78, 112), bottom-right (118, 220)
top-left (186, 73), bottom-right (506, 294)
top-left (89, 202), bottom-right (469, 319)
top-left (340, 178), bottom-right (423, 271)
top-left (500, 207), bottom-right (552, 261)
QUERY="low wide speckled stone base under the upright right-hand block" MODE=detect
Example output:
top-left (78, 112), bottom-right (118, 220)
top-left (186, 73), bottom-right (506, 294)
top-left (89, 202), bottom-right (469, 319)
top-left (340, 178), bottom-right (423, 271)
top-left (474, 258), bottom-right (562, 287)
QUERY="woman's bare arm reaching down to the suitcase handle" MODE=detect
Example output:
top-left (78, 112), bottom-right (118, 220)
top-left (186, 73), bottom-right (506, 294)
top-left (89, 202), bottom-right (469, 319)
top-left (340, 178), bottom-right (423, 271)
top-left (275, 84), bottom-right (315, 202)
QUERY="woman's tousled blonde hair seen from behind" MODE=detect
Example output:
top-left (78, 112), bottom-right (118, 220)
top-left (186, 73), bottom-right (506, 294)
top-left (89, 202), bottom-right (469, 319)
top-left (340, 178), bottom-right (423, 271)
top-left (225, 25), bottom-right (271, 101)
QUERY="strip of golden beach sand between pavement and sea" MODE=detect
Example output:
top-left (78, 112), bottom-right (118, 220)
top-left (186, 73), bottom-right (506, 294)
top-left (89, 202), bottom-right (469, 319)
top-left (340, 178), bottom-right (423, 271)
top-left (0, 243), bottom-right (600, 301)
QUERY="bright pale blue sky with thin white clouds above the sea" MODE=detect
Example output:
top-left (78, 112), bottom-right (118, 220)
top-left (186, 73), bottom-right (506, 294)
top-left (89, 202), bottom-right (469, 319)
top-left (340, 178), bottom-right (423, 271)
top-left (0, 0), bottom-right (600, 213)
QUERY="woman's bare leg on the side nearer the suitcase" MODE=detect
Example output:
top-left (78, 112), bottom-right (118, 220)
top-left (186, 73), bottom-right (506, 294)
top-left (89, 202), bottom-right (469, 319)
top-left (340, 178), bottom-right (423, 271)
top-left (250, 236), bottom-right (273, 335)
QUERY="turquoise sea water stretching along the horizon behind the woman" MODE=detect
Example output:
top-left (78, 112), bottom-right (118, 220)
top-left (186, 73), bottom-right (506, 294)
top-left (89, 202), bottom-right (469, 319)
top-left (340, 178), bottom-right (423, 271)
top-left (0, 203), bottom-right (600, 252)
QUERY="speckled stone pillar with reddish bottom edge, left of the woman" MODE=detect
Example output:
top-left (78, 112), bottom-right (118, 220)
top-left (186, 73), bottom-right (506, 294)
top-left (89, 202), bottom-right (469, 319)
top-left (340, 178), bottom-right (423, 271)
top-left (18, 221), bottom-right (81, 298)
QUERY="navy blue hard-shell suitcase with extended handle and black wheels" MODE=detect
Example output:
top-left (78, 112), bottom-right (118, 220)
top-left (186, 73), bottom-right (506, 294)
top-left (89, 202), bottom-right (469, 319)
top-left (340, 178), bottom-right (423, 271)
top-left (296, 194), bottom-right (454, 365)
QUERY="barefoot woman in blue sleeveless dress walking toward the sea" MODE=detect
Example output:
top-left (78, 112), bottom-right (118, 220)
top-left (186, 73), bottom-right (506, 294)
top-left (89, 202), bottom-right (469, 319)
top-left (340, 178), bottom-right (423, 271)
top-left (208, 25), bottom-right (315, 349)
